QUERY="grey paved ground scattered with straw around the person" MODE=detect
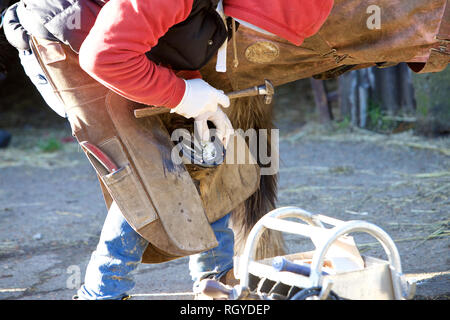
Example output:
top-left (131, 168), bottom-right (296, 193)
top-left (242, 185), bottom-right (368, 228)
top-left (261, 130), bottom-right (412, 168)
top-left (0, 84), bottom-right (450, 300)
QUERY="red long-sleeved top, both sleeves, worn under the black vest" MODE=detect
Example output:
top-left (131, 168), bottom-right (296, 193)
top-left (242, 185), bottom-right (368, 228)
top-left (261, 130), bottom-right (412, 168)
top-left (79, 0), bottom-right (333, 108)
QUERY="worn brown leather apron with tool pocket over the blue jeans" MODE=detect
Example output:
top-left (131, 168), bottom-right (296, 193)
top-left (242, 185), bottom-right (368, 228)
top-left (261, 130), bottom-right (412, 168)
top-left (32, 38), bottom-right (259, 263)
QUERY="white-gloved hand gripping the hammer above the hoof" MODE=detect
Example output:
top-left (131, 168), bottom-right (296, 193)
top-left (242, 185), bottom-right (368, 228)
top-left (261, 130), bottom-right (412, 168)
top-left (170, 79), bottom-right (234, 148)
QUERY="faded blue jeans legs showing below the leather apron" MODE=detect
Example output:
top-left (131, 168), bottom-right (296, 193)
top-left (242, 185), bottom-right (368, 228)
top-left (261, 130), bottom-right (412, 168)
top-left (77, 202), bottom-right (234, 300)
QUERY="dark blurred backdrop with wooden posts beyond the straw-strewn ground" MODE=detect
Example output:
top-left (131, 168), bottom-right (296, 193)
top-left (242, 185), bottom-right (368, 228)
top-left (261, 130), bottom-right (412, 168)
top-left (0, 29), bottom-right (450, 147)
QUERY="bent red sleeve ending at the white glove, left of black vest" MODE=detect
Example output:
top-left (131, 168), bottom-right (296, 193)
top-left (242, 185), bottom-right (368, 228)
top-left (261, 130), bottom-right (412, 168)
top-left (79, 0), bottom-right (193, 108)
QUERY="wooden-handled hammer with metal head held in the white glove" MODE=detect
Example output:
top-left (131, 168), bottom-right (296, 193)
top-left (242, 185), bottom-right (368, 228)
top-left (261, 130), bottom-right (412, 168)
top-left (134, 79), bottom-right (275, 118)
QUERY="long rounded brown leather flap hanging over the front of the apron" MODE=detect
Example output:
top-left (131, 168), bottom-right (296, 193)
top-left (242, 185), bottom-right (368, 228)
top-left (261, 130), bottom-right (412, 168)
top-left (106, 92), bottom-right (217, 254)
